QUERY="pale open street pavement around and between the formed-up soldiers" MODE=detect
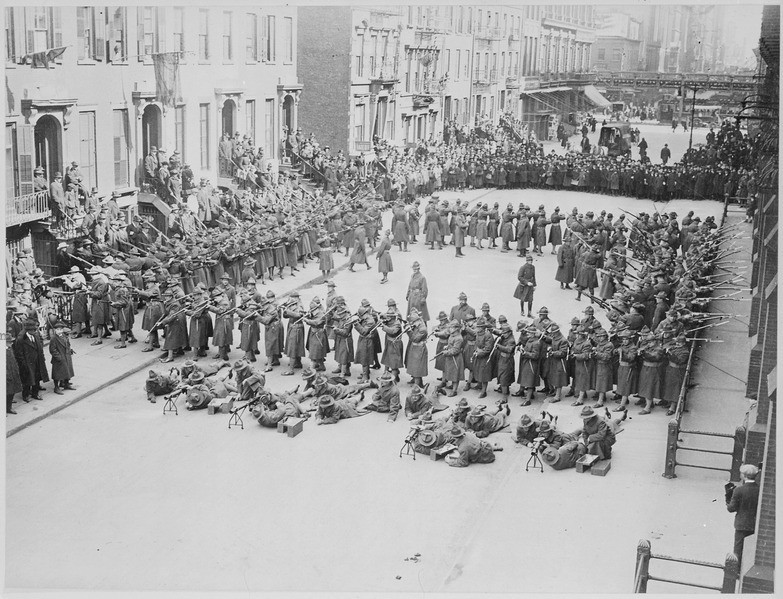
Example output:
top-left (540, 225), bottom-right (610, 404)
top-left (5, 185), bottom-right (750, 596)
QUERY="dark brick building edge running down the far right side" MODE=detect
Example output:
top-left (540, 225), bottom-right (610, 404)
top-left (740, 6), bottom-right (780, 593)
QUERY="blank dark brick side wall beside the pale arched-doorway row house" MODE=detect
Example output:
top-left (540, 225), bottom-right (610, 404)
top-left (297, 6), bottom-right (352, 155)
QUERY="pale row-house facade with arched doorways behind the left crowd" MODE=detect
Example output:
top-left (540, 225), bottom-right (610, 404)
top-left (5, 6), bottom-right (302, 265)
